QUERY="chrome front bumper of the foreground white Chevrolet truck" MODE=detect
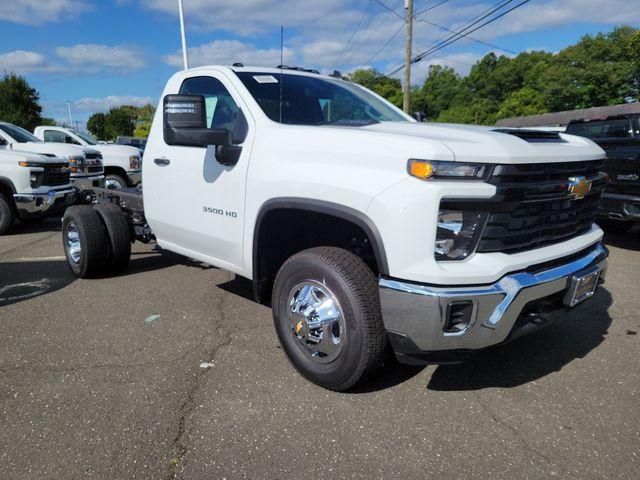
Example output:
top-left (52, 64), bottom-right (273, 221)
top-left (379, 244), bottom-right (608, 362)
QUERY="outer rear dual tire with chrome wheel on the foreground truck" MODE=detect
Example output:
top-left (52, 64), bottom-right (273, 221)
top-left (62, 205), bottom-right (109, 278)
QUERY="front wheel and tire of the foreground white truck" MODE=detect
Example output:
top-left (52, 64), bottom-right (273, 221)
top-left (272, 247), bottom-right (387, 391)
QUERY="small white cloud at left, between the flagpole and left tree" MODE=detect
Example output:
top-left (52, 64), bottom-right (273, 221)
top-left (56, 43), bottom-right (146, 73)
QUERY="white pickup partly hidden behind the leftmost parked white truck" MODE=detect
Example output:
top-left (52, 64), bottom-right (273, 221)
top-left (0, 122), bottom-right (104, 202)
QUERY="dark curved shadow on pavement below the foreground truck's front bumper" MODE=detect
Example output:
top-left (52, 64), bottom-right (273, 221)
top-left (427, 287), bottom-right (612, 391)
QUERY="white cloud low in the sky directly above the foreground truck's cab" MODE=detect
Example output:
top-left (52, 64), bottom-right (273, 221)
top-left (164, 40), bottom-right (295, 68)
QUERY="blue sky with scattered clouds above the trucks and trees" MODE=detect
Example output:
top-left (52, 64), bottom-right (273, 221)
top-left (0, 0), bottom-right (640, 127)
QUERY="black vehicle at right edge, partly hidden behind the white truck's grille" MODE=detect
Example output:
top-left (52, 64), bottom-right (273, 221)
top-left (567, 114), bottom-right (640, 233)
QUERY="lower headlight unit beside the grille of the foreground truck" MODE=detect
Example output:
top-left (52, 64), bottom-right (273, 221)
top-left (433, 210), bottom-right (487, 261)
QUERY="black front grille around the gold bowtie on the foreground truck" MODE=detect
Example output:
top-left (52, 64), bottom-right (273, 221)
top-left (477, 160), bottom-right (606, 253)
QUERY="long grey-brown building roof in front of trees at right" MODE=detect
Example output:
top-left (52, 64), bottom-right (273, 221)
top-left (496, 102), bottom-right (640, 127)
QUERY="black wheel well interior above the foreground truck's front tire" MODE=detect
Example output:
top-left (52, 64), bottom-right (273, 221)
top-left (253, 206), bottom-right (387, 303)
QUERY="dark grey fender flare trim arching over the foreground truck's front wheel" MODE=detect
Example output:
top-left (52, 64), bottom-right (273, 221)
top-left (252, 197), bottom-right (389, 298)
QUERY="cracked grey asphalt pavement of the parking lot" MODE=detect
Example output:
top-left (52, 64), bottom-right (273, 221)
top-left (0, 219), bottom-right (640, 479)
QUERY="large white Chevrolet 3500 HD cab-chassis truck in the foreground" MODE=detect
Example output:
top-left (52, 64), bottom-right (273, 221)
top-left (62, 66), bottom-right (608, 390)
